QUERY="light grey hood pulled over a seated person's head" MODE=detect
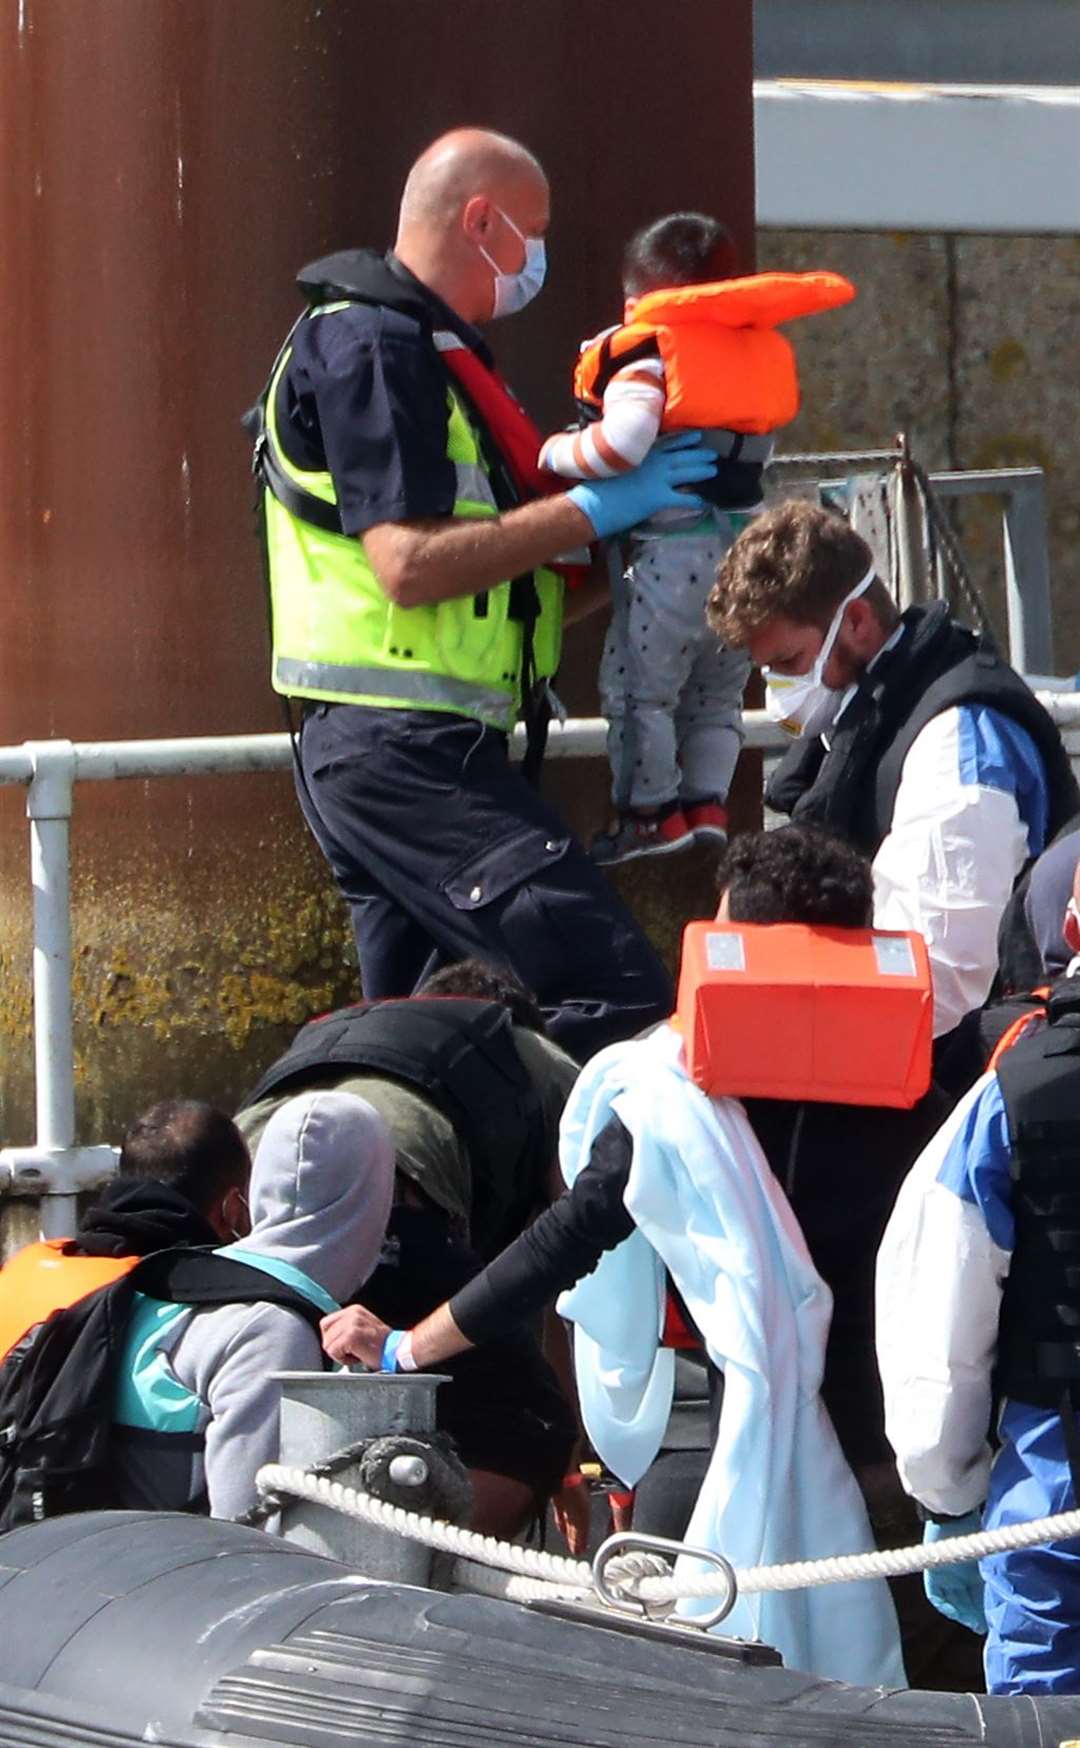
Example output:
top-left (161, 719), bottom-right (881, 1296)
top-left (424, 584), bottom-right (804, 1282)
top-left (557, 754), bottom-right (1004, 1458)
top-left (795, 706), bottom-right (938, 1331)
top-left (238, 1093), bottom-right (393, 1299)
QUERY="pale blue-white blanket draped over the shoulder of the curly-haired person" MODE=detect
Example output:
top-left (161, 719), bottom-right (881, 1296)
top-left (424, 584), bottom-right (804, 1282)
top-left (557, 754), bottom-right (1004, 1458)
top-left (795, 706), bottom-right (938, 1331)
top-left (559, 1026), bottom-right (907, 1687)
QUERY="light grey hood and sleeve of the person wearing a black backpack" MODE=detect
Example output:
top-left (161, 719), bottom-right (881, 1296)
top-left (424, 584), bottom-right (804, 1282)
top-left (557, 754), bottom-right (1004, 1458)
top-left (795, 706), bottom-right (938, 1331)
top-left (117, 1093), bottom-right (393, 1517)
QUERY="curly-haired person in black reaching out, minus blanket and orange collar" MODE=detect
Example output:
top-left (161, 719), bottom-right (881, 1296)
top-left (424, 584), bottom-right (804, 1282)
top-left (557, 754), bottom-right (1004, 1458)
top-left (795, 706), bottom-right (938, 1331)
top-left (325, 827), bottom-right (977, 1685)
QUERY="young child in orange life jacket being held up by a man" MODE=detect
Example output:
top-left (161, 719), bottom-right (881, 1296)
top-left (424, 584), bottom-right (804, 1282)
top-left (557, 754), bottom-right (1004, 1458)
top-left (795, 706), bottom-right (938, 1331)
top-left (540, 213), bottom-right (855, 864)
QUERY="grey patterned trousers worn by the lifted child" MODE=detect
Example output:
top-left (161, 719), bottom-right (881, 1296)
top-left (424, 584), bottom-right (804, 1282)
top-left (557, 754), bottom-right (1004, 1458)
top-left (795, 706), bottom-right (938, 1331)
top-left (599, 510), bottom-right (750, 809)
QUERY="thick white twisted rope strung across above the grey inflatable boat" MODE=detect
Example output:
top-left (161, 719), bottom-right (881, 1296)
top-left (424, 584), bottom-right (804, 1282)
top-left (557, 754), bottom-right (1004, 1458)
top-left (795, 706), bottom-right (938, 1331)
top-left (257, 1463), bottom-right (1080, 1603)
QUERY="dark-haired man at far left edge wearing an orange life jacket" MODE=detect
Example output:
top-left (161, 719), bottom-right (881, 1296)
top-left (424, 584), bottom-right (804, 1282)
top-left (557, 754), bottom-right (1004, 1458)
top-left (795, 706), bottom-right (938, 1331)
top-left (0, 1099), bottom-right (252, 1358)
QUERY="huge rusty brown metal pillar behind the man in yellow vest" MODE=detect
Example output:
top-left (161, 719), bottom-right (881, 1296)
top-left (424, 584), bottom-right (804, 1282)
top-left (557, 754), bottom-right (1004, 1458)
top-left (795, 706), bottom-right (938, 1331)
top-left (0, 0), bottom-right (753, 1141)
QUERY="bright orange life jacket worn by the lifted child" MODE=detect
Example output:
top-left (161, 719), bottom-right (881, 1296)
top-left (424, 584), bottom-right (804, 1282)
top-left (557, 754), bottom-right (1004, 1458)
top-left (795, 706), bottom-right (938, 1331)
top-left (573, 273), bottom-right (855, 434)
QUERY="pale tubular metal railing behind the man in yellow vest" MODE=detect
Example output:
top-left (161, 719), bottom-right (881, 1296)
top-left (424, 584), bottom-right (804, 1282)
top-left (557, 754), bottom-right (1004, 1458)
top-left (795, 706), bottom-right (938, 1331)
top-left (0, 692), bottom-right (1080, 1238)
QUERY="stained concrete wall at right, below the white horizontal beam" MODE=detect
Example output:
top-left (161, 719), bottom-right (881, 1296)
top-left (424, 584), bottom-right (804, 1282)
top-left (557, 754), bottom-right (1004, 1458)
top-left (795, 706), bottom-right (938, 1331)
top-left (758, 231), bottom-right (1080, 671)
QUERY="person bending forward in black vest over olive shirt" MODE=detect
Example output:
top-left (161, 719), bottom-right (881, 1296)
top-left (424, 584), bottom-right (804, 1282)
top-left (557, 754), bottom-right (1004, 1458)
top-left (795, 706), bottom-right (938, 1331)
top-left (238, 960), bottom-right (580, 1535)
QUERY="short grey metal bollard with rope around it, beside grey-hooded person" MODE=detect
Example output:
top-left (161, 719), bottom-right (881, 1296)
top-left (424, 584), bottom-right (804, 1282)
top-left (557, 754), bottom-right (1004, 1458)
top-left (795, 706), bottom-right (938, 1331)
top-left (276, 1372), bottom-right (447, 1584)
